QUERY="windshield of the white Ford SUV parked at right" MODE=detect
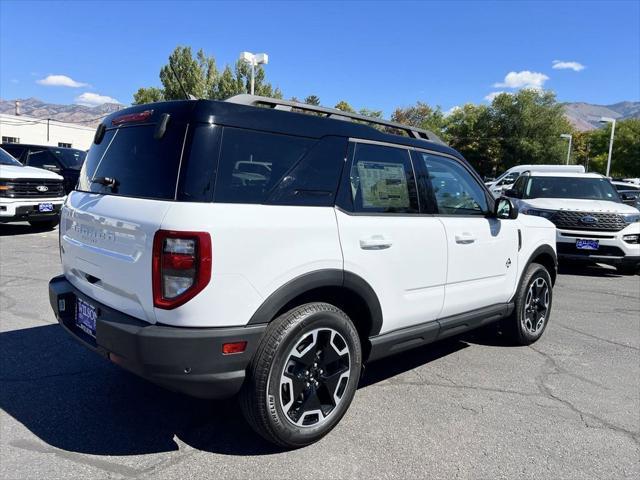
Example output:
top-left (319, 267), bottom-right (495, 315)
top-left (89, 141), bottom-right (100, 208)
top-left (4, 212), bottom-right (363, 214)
top-left (523, 177), bottom-right (620, 203)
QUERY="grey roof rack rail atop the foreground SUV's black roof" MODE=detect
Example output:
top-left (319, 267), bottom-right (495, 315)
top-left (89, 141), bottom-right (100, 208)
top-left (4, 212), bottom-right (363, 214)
top-left (225, 94), bottom-right (446, 145)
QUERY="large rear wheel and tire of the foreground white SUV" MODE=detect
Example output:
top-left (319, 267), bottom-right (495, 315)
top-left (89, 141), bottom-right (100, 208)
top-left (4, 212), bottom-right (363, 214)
top-left (240, 303), bottom-right (362, 448)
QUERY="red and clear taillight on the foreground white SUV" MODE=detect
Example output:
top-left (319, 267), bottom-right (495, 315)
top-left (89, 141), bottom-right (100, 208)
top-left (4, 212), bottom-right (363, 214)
top-left (152, 230), bottom-right (212, 309)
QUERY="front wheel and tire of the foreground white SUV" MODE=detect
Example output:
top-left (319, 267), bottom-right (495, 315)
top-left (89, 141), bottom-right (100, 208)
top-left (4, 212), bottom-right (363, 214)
top-left (503, 263), bottom-right (553, 345)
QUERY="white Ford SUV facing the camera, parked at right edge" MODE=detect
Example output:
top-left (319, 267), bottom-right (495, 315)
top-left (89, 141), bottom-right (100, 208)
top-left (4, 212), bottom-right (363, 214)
top-left (506, 172), bottom-right (640, 274)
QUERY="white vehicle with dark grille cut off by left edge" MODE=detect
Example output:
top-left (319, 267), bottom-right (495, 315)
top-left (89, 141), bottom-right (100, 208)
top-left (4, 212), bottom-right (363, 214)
top-left (0, 148), bottom-right (65, 229)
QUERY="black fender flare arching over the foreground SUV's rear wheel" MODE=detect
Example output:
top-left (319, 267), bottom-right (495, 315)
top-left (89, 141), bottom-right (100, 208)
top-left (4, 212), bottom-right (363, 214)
top-left (249, 269), bottom-right (382, 337)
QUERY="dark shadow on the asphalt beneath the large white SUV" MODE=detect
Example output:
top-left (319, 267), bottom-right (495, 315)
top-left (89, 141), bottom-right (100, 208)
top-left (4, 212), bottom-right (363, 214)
top-left (0, 325), bottom-right (466, 455)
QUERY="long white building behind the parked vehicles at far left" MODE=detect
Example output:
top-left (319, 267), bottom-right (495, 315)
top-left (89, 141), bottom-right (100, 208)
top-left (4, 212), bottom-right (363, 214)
top-left (0, 113), bottom-right (96, 150)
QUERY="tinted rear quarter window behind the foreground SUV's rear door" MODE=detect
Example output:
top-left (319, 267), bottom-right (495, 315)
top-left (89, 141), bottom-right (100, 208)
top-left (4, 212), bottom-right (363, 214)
top-left (214, 127), bottom-right (316, 203)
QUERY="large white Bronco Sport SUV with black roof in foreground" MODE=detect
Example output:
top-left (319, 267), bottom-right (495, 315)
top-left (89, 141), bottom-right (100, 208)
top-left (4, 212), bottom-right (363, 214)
top-left (49, 95), bottom-right (556, 447)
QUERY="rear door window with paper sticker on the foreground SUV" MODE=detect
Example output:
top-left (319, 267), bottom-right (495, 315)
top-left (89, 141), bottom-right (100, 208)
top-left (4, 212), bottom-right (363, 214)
top-left (350, 143), bottom-right (420, 213)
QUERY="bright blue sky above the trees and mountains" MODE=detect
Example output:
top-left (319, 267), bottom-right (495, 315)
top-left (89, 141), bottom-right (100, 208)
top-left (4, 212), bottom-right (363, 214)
top-left (0, 0), bottom-right (640, 114)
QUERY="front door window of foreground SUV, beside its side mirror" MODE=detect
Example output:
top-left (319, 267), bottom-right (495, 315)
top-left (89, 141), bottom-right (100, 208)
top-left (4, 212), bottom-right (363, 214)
top-left (416, 152), bottom-right (489, 215)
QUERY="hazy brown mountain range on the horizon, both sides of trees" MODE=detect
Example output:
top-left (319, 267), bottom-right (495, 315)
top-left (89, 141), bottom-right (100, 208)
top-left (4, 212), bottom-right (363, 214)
top-left (0, 98), bottom-right (640, 131)
